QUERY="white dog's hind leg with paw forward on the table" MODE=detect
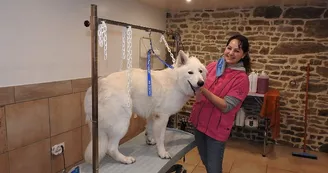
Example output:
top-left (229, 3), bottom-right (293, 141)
top-left (107, 115), bottom-right (136, 164)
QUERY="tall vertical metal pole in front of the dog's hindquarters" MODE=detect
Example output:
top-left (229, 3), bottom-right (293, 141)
top-left (90, 4), bottom-right (99, 173)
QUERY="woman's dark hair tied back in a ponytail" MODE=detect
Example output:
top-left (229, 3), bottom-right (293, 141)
top-left (226, 34), bottom-right (252, 74)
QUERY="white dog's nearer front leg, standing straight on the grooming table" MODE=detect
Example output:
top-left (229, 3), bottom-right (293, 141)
top-left (153, 115), bottom-right (171, 159)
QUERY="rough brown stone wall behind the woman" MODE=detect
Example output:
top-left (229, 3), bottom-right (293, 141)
top-left (167, 1), bottom-right (328, 150)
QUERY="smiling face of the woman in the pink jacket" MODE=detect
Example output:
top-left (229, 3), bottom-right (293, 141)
top-left (223, 39), bottom-right (245, 64)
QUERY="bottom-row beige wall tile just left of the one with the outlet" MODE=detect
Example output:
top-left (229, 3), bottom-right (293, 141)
top-left (9, 139), bottom-right (51, 173)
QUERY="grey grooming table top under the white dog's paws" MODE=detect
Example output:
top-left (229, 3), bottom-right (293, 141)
top-left (80, 128), bottom-right (195, 173)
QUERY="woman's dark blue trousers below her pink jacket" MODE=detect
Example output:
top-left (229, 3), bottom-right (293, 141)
top-left (194, 129), bottom-right (225, 173)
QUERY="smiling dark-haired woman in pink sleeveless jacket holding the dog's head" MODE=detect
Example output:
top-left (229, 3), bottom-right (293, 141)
top-left (190, 35), bottom-right (251, 173)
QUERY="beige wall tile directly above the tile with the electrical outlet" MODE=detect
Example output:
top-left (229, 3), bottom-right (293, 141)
top-left (49, 93), bottom-right (82, 136)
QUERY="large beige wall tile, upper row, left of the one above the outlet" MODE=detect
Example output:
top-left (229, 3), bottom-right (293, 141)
top-left (6, 99), bottom-right (50, 150)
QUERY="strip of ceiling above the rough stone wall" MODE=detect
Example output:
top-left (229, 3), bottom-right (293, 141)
top-left (139, 0), bottom-right (313, 11)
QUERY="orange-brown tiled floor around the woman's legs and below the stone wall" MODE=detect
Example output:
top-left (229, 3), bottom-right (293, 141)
top-left (178, 139), bottom-right (328, 173)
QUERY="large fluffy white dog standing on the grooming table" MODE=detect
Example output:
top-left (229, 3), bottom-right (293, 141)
top-left (84, 51), bottom-right (207, 164)
